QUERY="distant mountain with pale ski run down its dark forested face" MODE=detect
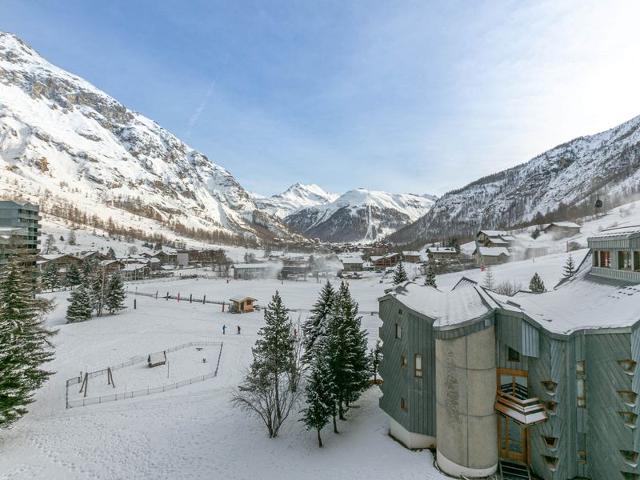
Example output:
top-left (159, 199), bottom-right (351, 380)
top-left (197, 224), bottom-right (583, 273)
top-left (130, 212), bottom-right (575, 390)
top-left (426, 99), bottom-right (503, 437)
top-left (285, 188), bottom-right (435, 242)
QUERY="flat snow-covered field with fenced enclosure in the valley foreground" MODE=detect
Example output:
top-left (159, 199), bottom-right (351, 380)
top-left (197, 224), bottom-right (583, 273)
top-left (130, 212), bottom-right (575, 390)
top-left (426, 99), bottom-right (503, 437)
top-left (0, 279), bottom-right (450, 480)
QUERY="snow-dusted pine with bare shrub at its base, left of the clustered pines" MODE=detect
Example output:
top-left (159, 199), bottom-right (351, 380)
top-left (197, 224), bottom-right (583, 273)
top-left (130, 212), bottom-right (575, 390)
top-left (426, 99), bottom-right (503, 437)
top-left (233, 292), bottom-right (300, 438)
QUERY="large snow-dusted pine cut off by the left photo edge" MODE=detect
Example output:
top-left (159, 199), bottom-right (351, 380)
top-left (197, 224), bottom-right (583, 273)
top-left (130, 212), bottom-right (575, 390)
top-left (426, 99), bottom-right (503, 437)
top-left (0, 261), bottom-right (54, 428)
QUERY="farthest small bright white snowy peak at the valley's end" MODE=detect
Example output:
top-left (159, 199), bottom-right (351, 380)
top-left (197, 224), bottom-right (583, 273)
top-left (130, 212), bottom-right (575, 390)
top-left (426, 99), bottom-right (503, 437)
top-left (253, 183), bottom-right (338, 218)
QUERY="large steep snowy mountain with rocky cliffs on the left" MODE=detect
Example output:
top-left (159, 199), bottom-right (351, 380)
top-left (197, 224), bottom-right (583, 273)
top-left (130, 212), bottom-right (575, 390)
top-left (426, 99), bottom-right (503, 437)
top-left (0, 32), bottom-right (296, 244)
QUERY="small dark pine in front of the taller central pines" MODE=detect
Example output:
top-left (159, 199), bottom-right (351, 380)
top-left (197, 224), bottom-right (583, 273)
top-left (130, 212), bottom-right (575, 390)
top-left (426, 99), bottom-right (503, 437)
top-left (301, 338), bottom-right (336, 448)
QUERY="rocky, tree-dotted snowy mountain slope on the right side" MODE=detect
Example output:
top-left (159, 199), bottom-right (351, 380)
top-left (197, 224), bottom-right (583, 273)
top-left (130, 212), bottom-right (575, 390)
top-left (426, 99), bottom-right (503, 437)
top-left (389, 116), bottom-right (640, 243)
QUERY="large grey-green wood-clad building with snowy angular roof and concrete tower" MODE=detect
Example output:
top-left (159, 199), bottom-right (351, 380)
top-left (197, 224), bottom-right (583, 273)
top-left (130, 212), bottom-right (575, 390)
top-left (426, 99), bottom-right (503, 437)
top-left (379, 226), bottom-right (640, 480)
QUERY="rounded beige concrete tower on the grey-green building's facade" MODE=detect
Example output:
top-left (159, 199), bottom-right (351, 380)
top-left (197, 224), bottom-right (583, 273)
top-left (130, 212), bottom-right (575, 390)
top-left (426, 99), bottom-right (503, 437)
top-left (436, 327), bottom-right (498, 477)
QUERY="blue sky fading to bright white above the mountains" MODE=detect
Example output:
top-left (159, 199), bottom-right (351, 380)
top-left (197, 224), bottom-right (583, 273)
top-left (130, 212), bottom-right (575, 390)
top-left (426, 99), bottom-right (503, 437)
top-left (0, 0), bottom-right (640, 195)
